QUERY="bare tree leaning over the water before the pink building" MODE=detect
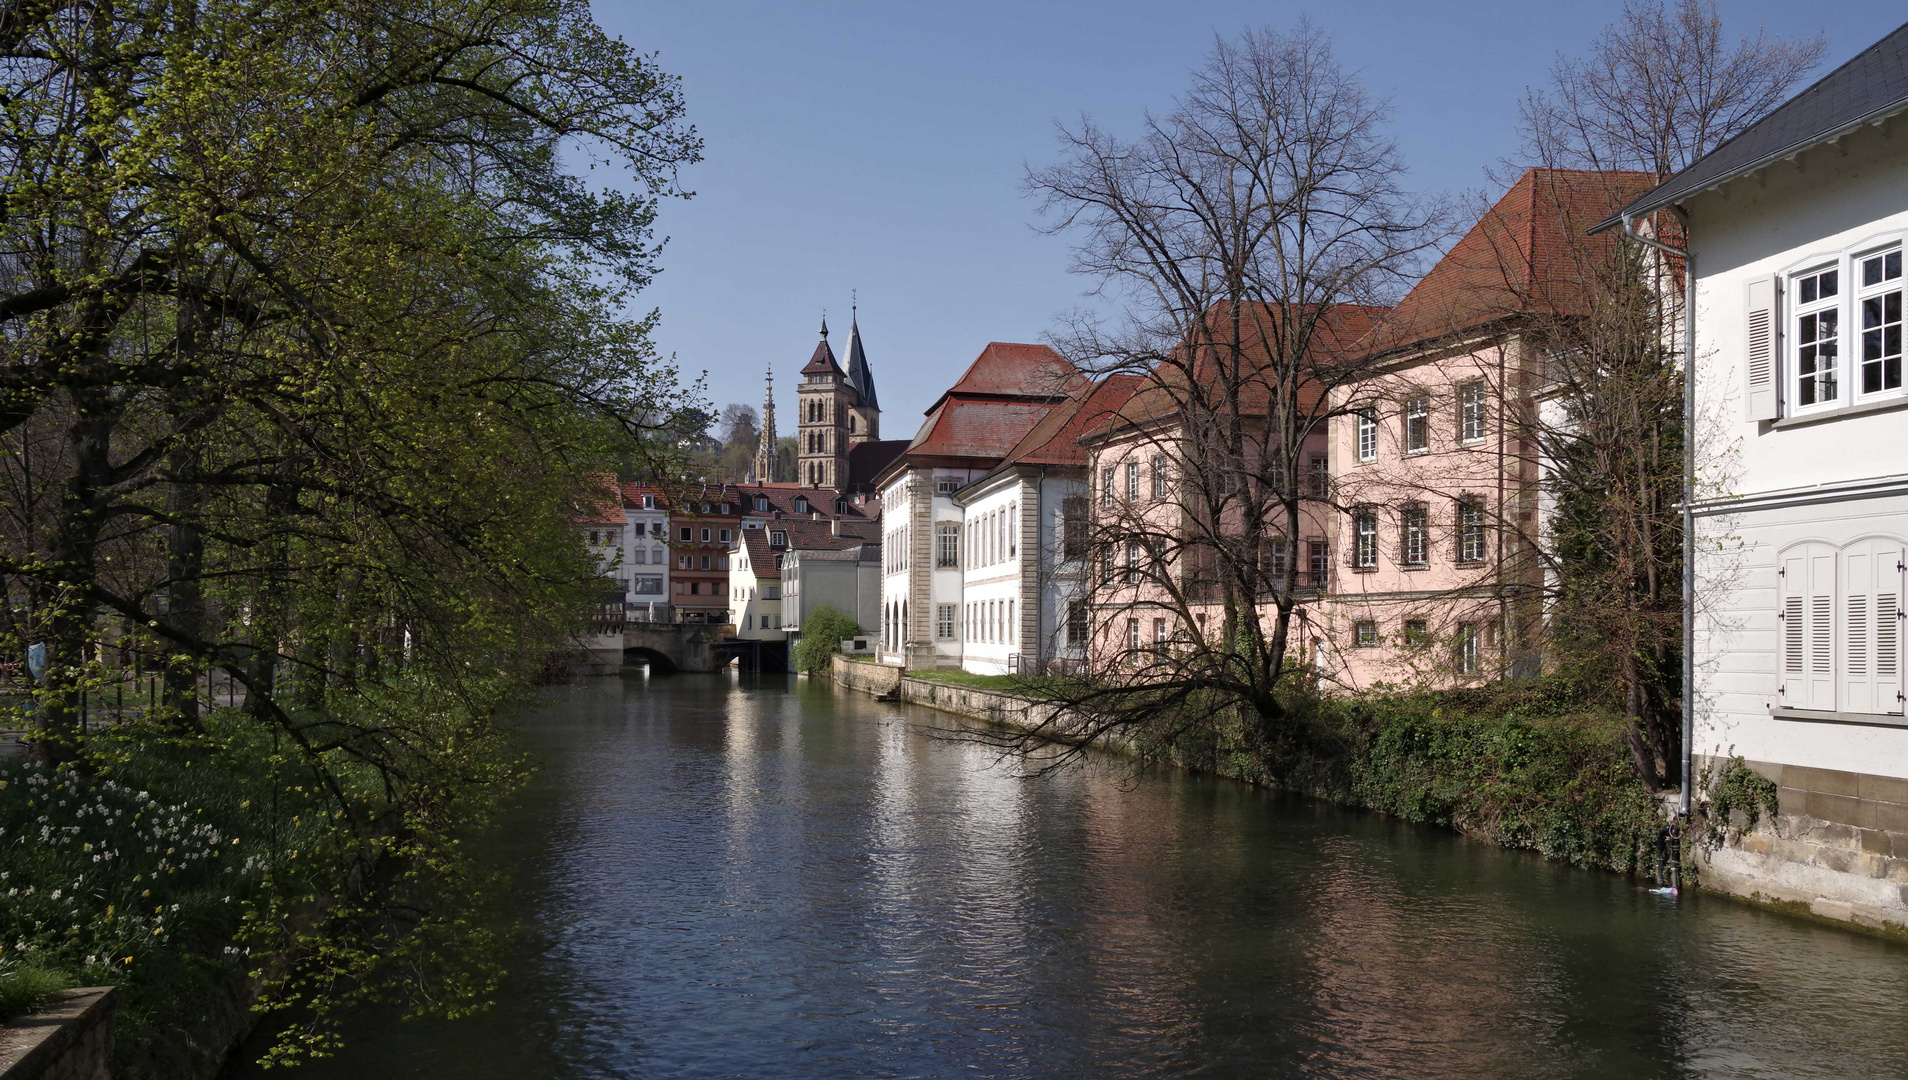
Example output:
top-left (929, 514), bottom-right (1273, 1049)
top-left (1021, 23), bottom-right (1444, 770)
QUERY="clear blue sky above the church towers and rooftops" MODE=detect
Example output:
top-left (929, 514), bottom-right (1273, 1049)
top-left (597, 0), bottom-right (1908, 439)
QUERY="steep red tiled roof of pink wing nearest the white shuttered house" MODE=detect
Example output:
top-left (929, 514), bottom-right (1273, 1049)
top-left (1360, 168), bottom-right (1654, 355)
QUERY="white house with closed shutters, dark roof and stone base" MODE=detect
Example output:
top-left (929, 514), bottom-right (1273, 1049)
top-left (1626, 27), bottom-right (1908, 925)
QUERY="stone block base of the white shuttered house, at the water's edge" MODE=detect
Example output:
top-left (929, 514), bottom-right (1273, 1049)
top-left (1698, 759), bottom-right (1908, 931)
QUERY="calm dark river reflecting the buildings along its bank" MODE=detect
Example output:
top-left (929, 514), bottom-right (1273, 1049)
top-left (234, 675), bottom-right (1908, 1080)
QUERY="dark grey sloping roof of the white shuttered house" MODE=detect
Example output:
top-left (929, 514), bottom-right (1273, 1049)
top-left (1591, 23), bottom-right (1908, 233)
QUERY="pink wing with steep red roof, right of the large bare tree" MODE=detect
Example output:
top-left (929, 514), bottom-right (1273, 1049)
top-left (1320, 170), bottom-right (1650, 689)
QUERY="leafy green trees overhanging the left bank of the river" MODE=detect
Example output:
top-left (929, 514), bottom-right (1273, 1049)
top-left (0, 0), bottom-right (700, 1068)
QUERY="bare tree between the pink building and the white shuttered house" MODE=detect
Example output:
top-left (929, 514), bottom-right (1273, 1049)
top-left (1523, 0), bottom-right (1826, 786)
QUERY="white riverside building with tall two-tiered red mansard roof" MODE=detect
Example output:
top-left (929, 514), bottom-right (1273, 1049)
top-left (876, 342), bottom-right (1086, 668)
